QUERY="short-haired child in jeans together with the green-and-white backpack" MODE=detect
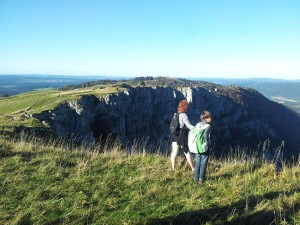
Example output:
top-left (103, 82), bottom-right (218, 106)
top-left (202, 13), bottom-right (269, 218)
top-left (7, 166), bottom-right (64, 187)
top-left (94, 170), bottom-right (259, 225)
top-left (189, 111), bottom-right (212, 183)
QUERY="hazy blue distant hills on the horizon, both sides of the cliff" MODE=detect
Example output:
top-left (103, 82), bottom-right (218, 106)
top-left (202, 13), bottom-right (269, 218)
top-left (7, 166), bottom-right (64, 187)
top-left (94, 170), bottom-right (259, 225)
top-left (0, 74), bottom-right (300, 113)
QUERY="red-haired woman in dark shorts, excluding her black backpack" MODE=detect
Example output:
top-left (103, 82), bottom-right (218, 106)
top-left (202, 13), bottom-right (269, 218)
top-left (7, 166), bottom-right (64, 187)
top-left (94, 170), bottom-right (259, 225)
top-left (171, 100), bottom-right (194, 171)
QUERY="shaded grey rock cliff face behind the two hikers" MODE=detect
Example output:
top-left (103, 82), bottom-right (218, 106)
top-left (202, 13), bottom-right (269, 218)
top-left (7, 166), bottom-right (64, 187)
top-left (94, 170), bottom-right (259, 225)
top-left (33, 87), bottom-right (300, 157)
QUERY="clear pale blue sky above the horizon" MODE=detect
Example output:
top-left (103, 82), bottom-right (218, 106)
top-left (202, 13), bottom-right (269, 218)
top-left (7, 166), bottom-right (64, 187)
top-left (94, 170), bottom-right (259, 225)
top-left (0, 0), bottom-right (300, 79)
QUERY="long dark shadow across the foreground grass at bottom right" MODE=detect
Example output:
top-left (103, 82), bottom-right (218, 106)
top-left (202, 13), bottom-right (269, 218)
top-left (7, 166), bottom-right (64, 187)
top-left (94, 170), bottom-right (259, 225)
top-left (146, 189), bottom-right (300, 225)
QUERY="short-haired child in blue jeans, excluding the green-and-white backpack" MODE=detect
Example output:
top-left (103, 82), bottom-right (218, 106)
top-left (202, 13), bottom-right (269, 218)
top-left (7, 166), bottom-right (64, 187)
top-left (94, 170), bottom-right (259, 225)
top-left (194, 111), bottom-right (212, 183)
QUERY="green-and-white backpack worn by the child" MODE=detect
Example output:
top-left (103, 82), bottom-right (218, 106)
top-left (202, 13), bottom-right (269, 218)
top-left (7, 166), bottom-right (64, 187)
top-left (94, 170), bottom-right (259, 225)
top-left (188, 124), bottom-right (209, 153)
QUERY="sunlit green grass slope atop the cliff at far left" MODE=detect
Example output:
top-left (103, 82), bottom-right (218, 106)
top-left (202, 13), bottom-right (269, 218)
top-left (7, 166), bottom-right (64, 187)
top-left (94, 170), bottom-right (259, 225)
top-left (0, 85), bottom-right (124, 130)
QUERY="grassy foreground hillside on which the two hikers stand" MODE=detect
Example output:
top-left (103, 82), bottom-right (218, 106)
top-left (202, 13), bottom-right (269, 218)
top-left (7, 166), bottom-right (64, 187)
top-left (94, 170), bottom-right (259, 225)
top-left (0, 134), bottom-right (300, 225)
